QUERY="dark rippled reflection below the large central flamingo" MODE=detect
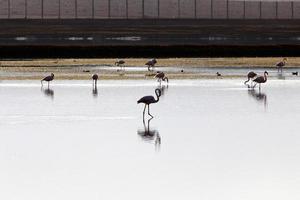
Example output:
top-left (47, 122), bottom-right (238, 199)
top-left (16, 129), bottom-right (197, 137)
top-left (137, 118), bottom-right (161, 151)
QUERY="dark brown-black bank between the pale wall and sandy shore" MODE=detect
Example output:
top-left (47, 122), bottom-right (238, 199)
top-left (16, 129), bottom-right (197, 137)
top-left (0, 19), bottom-right (300, 58)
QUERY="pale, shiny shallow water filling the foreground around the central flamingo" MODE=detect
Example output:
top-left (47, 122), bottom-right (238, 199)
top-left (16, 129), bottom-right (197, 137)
top-left (0, 79), bottom-right (300, 200)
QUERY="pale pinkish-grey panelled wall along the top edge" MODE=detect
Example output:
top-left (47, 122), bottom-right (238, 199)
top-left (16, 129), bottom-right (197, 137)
top-left (0, 0), bottom-right (300, 19)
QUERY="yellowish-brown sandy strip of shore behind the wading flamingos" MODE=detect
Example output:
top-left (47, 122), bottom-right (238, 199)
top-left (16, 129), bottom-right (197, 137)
top-left (0, 57), bottom-right (300, 80)
